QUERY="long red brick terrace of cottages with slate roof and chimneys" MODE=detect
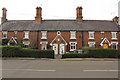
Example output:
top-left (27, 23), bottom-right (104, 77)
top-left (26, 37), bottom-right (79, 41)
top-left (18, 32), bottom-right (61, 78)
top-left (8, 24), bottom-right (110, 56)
top-left (0, 7), bottom-right (120, 54)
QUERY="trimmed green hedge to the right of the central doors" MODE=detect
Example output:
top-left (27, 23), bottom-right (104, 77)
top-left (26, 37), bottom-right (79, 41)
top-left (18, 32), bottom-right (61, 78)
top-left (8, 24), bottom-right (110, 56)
top-left (62, 48), bottom-right (118, 58)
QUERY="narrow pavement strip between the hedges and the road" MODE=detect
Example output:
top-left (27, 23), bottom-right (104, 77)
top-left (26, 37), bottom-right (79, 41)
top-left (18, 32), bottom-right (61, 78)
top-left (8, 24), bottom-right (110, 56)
top-left (2, 58), bottom-right (119, 61)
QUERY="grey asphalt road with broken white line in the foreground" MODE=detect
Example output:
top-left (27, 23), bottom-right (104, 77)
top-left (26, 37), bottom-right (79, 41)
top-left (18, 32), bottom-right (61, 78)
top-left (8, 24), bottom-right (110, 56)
top-left (2, 59), bottom-right (118, 78)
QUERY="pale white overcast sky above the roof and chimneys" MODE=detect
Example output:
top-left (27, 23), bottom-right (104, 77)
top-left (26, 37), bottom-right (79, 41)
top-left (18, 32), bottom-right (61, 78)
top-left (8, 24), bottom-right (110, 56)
top-left (0, 0), bottom-right (120, 20)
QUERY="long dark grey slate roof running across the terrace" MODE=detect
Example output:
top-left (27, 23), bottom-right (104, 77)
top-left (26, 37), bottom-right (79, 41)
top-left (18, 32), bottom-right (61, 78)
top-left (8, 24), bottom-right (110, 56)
top-left (0, 20), bottom-right (118, 31)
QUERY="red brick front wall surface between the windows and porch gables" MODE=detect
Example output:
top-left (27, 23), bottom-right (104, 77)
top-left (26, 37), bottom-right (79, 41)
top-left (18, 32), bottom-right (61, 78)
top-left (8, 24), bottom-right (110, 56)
top-left (3, 31), bottom-right (120, 50)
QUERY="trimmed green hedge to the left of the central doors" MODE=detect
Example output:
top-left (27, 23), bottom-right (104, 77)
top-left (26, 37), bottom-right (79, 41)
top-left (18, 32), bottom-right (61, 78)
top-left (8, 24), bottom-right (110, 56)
top-left (2, 46), bottom-right (54, 58)
